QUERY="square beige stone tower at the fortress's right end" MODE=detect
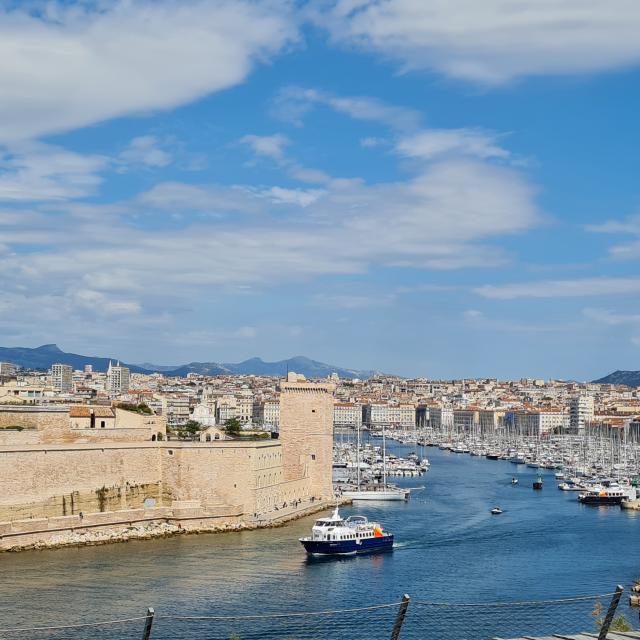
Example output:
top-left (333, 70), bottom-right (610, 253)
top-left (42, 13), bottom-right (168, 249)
top-left (280, 373), bottom-right (335, 500)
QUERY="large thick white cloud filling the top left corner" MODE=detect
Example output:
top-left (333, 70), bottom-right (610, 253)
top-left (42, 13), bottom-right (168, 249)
top-left (0, 0), bottom-right (297, 142)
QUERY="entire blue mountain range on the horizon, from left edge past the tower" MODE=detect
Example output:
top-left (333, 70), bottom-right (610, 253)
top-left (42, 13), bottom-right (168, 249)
top-left (0, 344), bottom-right (375, 379)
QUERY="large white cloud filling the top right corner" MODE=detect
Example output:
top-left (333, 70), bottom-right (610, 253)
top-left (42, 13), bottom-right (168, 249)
top-left (316, 0), bottom-right (640, 84)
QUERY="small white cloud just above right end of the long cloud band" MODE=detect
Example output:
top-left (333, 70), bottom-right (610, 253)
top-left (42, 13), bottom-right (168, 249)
top-left (396, 129), bottom-right (510, 160)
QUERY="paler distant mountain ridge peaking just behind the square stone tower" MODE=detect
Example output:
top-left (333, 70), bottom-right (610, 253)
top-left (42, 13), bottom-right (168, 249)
top-left (165, 356), bottom-right (375, 379)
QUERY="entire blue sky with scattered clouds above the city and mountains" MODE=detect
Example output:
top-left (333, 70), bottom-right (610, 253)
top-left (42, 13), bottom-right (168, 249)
top-left (0, 0), bottom-right (640, 380)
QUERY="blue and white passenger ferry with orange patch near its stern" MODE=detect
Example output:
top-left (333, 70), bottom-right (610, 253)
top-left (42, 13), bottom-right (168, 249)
top-left (300, 507), bottom-right (393, 555)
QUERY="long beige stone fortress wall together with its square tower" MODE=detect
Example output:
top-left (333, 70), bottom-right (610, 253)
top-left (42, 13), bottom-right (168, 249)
top-left (0, 374), bottom-right (333, 550)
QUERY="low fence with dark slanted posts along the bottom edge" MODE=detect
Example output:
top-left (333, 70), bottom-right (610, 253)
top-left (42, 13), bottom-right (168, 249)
top-left (0, 587), bottom-right (640, 640)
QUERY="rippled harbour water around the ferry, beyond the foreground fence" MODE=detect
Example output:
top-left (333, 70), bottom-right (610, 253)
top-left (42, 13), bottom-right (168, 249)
top-left (0, 443), bottom-right (640, 638)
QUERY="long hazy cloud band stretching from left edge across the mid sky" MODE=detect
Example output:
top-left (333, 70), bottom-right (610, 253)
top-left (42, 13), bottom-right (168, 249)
top-left (0, 156), bottom-right (539, 324)
